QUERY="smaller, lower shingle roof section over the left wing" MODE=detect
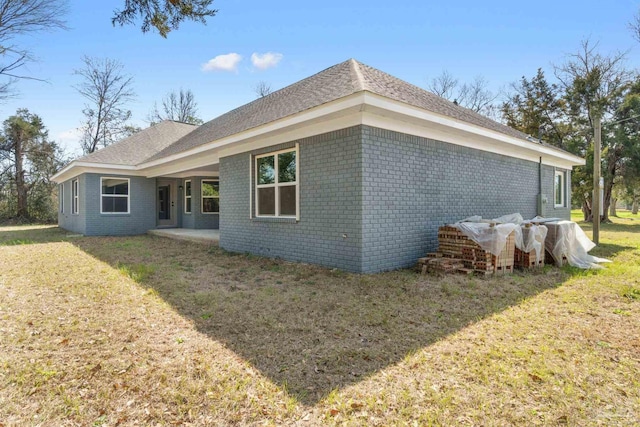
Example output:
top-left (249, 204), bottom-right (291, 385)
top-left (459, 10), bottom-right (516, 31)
top-left (76, 120), bottom-right (196, 166)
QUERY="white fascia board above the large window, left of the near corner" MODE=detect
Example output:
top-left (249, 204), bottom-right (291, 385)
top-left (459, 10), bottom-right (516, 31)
top-left (139, 92), bottom-right (364, 169)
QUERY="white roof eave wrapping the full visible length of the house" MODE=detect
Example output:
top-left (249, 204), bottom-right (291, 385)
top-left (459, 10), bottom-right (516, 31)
top-left (52, 90), bottom-right (585, 182)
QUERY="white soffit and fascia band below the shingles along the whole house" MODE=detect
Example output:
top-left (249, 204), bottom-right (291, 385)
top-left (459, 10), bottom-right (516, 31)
top-left (52, 91), bottom-right (585, 182)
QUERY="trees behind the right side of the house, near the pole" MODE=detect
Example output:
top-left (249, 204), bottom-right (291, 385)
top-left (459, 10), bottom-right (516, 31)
top-left (429, 38), bottom-right (640, 221)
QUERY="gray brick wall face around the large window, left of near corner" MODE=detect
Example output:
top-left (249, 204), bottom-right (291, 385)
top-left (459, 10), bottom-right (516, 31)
top-left (220, 127), bottom-right (362, 271)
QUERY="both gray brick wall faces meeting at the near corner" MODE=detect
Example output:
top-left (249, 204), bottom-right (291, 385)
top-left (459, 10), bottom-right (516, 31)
top-left (220, 126), bottom-right (570, 272)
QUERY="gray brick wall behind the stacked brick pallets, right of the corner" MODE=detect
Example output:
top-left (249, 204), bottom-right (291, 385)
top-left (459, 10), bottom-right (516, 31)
top-left (362, 126), bottom-right (569, 272)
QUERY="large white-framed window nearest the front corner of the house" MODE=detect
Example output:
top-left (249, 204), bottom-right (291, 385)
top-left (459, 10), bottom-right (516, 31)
top-left (255, 149), bottom-right (298, 218)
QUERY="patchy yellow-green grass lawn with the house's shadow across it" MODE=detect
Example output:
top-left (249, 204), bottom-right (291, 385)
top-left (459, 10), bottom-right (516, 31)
top-left (0, 212), bottom-right (640, 427)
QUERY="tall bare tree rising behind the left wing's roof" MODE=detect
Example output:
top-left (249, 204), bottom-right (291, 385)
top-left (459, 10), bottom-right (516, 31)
top-left (75, 56), bottom-right (135, 154)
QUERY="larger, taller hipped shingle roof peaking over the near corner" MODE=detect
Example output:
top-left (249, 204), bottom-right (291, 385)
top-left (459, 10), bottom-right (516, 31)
top-left (148, 59), bottom-right (527, 165)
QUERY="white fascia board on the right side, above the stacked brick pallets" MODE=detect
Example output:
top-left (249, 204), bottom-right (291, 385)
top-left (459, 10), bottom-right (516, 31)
top-left (365, 92), bottom-right (585, 169)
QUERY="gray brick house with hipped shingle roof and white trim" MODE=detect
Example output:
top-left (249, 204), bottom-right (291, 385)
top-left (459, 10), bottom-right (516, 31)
top-left (53, 60), bottom-right (584, 272)
